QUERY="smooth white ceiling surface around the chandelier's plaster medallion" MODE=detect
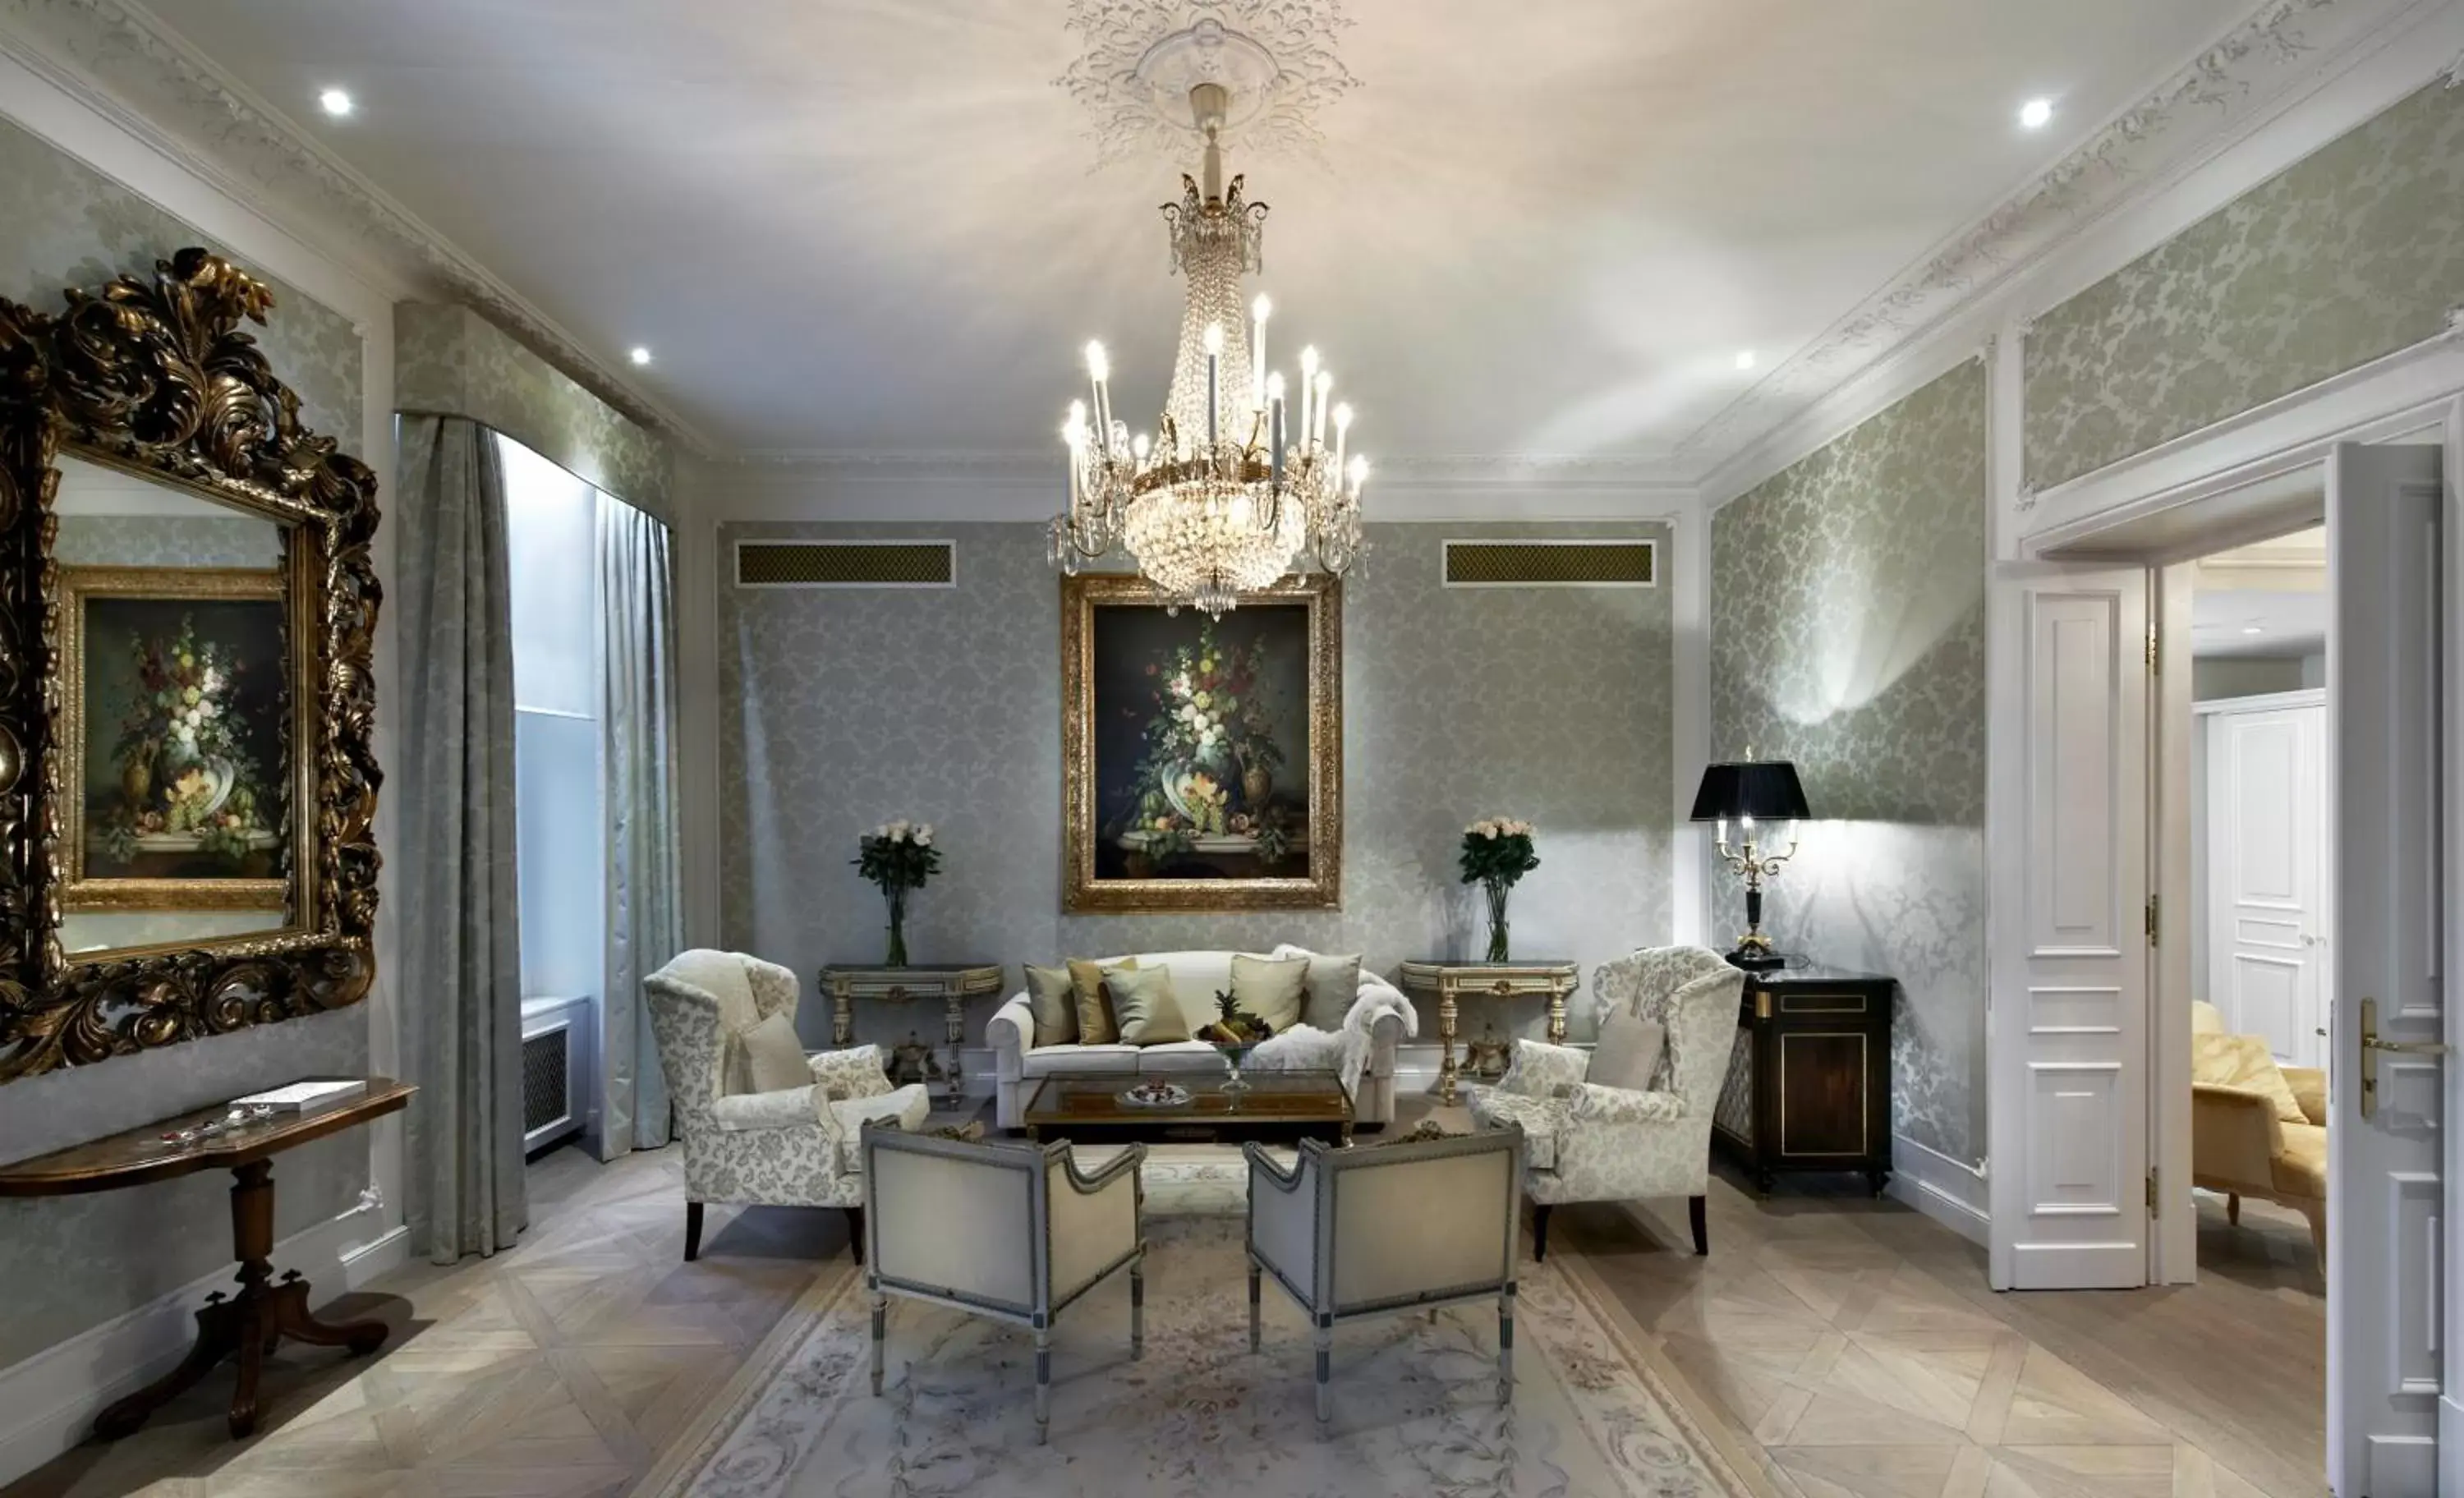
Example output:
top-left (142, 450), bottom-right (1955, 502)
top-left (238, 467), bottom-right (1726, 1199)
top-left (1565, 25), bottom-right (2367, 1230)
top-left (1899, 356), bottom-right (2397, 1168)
top-left (135, 0), bottom-right (2252, 471)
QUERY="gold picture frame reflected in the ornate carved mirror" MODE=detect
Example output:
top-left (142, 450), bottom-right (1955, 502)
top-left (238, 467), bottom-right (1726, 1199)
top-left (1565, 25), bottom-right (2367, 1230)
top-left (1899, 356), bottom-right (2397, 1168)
top-left (59, 552), bottom-right (315, 912)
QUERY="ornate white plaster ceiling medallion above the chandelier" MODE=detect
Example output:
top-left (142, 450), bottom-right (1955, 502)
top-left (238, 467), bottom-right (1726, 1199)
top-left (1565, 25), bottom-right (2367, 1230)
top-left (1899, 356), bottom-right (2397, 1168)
top-left (1055, 0), bottom-right (1358, 165)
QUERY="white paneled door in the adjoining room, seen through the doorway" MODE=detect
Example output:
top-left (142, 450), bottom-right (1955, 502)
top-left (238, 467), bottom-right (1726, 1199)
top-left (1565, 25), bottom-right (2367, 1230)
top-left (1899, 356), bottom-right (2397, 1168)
top-left (2200, 697), bottom-right (2328, 1067)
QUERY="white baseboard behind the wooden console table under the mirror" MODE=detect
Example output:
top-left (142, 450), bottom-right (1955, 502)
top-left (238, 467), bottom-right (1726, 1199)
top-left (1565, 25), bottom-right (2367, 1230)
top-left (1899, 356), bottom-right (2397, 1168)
top-left (0, 1210), bottom-right (392, 1486)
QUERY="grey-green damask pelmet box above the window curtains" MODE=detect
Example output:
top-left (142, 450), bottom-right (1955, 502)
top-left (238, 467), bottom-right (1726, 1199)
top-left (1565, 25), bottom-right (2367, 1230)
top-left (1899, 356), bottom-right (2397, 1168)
top-left (394, 301), bottom-right (675, 525)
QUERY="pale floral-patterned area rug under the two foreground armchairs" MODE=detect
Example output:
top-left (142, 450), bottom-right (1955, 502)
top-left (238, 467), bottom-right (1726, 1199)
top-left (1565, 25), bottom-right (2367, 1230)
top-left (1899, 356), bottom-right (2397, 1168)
top-left (670, 1217), bottom-right (1754, 1498)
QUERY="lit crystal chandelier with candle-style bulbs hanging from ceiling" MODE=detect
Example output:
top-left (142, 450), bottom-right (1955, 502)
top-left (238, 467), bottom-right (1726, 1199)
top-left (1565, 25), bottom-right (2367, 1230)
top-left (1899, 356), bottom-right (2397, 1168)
top-left (1052, 84), bottom-right (1370, 616)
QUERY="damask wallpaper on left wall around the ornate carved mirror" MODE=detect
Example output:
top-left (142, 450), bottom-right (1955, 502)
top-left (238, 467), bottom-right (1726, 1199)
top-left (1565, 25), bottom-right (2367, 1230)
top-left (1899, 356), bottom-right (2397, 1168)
top-left (0, 121), bottom-right (370, 1367)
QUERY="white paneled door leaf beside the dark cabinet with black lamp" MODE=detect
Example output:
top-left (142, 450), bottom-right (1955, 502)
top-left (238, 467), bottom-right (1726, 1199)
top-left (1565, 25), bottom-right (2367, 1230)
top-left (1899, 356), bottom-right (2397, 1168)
top-left (1988, 567), bottom-right (2149, 1289)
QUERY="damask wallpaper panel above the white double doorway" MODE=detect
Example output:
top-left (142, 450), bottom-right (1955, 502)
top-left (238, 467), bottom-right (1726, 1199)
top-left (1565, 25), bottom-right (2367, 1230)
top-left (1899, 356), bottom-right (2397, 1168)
top-left (2023, 81), bottom-right (2464, 488)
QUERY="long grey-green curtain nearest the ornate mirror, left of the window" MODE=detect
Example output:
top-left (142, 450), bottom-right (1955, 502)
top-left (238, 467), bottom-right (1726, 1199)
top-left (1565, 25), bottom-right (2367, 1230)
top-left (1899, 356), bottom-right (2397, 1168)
top-left (387, 414), bottom-right (530, 1264)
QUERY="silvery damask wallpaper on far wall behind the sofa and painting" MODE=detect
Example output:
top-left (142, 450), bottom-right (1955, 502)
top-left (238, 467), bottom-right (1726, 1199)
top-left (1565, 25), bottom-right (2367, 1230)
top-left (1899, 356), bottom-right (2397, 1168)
top-left (719, 525), bottom-right (1671, 1045)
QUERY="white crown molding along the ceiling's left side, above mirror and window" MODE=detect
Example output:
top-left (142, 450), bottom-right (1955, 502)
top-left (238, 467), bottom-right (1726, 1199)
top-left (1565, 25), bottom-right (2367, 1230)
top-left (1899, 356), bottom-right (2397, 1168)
top-left (0, 0), bottom-right (715, 453)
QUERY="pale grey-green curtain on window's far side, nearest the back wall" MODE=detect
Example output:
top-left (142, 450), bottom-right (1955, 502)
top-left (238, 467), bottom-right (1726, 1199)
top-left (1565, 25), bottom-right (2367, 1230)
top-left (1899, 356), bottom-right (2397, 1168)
top-left (599, 493), bottom-right (685, 1160)
